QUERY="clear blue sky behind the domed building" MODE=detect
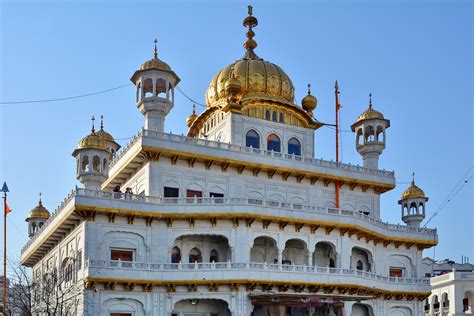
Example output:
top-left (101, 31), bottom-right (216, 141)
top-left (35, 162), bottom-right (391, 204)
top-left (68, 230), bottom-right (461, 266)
top-left (0, 0), bottom-right (474, 262)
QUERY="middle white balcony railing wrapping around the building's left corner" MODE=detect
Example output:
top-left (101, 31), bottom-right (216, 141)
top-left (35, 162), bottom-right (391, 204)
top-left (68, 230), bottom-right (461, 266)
top-left (21, 187), bottom-right (437, 253)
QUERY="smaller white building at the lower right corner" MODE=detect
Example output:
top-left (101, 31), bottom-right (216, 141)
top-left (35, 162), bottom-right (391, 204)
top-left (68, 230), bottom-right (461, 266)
top-left (423, 258), bottom-right (474, 316)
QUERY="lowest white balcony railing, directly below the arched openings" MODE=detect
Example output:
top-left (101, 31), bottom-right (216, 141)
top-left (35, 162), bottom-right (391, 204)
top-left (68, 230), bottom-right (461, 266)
top-left (85, 259), bottom-right (430, 286)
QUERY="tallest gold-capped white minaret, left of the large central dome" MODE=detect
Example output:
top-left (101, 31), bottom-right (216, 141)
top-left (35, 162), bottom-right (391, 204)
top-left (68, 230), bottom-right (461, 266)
top-left (130, 39), bottom-right (180, 133)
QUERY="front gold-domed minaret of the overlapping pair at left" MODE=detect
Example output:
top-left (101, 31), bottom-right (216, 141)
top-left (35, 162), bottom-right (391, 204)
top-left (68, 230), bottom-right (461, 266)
top-left (72, 117), bottom-right (112, 191)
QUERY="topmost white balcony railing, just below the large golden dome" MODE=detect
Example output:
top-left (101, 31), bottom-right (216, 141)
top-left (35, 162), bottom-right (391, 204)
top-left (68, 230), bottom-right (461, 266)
top-left (109, 129), bottom-right (395, 177)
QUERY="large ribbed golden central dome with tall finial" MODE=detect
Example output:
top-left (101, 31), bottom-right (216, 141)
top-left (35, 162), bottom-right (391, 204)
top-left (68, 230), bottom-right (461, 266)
top-left (205, 6), bottom-right (295, 108)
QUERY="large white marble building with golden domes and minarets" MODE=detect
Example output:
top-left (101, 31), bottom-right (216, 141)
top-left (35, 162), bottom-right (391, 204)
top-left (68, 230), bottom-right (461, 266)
top-left (21, 4), bottom-right (437, 316)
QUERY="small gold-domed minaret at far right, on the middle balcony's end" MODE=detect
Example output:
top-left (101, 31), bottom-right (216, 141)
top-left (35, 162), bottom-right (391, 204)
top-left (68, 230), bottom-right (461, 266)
top-left (398, 173), bottom-right (428, 227)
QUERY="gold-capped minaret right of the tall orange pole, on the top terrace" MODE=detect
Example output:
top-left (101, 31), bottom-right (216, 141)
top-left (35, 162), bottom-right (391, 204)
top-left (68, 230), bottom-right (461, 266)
top-left (351, 93), bottom-right (390, 169)
